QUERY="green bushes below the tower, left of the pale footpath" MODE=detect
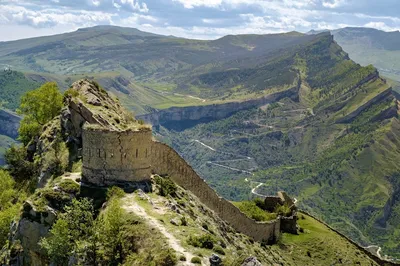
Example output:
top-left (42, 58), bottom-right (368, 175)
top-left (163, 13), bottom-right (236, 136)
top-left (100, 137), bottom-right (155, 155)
top-left (41, 189), bottom-right (177, 266)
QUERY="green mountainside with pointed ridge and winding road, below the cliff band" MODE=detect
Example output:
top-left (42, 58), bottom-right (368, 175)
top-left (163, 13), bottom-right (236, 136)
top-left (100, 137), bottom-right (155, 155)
top-left (154, 32), bottom-right (400, 256)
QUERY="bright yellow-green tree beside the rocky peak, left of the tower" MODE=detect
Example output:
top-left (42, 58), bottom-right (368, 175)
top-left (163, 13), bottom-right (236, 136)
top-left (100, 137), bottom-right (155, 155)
top-left (17, 82), bottom-right (63, 145)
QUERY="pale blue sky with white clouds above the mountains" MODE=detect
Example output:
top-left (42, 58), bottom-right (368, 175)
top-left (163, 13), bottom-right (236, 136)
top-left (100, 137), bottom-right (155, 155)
top-left (0, 0), bottom-right (400, 41)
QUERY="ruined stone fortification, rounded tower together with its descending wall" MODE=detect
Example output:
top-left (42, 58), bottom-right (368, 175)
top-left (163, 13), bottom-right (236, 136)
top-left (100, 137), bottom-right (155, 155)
top-left (82, 126), bottom-right (293, 241)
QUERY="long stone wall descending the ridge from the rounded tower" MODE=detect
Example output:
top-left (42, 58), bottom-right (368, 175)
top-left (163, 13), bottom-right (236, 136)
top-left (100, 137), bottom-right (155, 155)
top-left (151, 142), bottom-right (280, 241)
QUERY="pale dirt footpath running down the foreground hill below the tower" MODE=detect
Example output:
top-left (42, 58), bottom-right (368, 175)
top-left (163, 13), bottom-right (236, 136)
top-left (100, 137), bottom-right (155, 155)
top-left (122, 194), bottom-right (194, 266)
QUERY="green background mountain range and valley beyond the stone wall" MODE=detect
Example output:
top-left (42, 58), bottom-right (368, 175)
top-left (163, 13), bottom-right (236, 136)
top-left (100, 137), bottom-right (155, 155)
top-left (0, 26), bottom-right (400, 256)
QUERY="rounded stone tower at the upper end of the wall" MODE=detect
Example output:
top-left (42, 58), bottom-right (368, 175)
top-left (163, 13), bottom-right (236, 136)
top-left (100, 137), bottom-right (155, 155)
top-left (82, 126), bottom-right (152, 186)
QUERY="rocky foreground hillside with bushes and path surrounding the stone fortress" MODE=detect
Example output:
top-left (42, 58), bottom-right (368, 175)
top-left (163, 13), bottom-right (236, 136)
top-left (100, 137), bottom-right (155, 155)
top-left (0, 80), bottom-right (385, 266)
